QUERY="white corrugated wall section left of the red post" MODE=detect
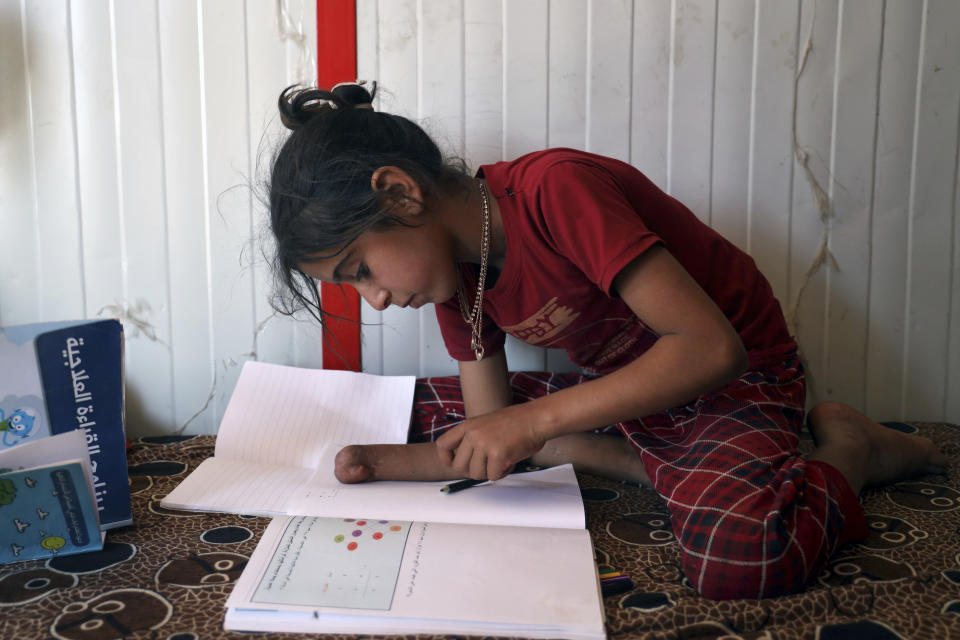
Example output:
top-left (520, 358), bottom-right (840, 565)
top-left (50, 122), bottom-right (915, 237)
top-left (0, 0), bottom-right (320, 435)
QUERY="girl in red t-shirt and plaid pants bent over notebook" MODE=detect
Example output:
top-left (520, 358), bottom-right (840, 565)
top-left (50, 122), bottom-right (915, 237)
top-left (270, 84), bottom-right (946, 598)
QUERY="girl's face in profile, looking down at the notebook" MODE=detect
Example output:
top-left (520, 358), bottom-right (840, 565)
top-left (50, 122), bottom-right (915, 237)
top-left (299, 221), bottom-right (457, 310)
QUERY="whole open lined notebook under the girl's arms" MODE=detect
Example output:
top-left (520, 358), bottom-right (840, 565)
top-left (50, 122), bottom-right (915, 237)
top-left (161, 362), bottom-right (585, 529)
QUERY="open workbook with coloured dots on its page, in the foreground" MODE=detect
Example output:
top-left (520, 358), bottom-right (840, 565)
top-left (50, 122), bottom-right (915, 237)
top-left (224, 516), bottom-right (605, 640)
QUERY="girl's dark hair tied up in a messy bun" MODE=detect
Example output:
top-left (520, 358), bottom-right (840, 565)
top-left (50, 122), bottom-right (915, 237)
top-left (269, 82), bottom-right (468, 324)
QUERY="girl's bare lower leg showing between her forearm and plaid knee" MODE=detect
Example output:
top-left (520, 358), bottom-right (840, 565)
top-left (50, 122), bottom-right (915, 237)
top-left (530, 433), bottom-right (653, 487)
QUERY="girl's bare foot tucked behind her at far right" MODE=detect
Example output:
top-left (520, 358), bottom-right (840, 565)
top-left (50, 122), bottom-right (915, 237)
top-left (807, 402), bottom-right (947, 493)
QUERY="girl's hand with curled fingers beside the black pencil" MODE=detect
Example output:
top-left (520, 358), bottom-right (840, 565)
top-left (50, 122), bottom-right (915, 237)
top-left (437, 405), bottom-right (546, 480)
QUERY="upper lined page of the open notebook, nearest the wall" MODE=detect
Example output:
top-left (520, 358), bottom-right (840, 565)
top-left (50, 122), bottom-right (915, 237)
top-left (214, 361), bottom-right (415, 468)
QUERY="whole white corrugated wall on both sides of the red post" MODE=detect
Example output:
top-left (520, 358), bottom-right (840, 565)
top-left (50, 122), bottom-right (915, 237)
top-left (0, 0), bottom-right (960, 435)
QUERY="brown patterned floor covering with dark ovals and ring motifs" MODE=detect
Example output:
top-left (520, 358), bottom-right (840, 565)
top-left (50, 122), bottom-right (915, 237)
top-left (0, 423), bottom-right (960, 640)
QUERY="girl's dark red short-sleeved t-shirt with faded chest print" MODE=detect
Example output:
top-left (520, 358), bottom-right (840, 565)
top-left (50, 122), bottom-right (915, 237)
top-left (436, 149), bottom-right (795, 374)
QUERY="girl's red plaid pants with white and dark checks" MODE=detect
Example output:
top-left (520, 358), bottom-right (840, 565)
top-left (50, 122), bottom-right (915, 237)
top-left (410, 356), bottom-right (867, 599)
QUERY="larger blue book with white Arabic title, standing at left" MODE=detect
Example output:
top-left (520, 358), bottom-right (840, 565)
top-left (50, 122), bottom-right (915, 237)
top-left (0, 320), bottom-right (132, 529)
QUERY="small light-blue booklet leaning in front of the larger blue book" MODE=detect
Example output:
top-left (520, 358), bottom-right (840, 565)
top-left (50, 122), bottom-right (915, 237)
top-left (0, 431), bottom-right (103, 564)
